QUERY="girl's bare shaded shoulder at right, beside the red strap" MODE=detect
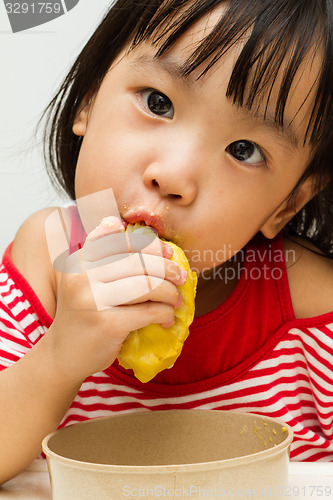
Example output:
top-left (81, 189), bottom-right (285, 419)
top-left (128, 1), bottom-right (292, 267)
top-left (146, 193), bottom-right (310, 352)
top-left (283, 236), bottom-right (333, 318)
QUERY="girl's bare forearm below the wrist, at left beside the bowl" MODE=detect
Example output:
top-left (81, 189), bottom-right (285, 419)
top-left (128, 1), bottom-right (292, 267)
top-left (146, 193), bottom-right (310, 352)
top-left (0, 327), bottom-right (81, 484)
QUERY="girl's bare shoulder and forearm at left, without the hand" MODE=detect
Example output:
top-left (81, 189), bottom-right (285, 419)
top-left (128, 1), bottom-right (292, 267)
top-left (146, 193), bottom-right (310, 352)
top-left (0, 208), bottom-right (80, 484)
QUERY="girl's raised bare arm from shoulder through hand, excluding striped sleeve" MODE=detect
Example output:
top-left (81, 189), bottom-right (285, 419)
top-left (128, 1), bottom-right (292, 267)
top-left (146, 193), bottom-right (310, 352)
top-left (0, 208), bottom-right (183, 484)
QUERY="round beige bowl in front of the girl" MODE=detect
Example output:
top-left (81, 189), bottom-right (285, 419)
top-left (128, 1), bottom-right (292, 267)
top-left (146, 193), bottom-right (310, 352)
top-left (43, 410), bottom-right (292, 500)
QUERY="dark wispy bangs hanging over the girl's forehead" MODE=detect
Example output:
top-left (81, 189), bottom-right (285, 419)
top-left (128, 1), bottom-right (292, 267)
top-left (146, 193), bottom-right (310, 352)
top-left (131, 0), bottom-right (333, 144)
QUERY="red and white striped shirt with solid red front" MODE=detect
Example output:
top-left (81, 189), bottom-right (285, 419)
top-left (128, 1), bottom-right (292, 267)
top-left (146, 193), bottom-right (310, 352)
top-left (0, 229), bottom-right (333, 461)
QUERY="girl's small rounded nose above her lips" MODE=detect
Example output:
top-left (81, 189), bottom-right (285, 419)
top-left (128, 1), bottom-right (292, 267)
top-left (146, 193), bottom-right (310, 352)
top-left (143, 147), bottom-right (200, 205)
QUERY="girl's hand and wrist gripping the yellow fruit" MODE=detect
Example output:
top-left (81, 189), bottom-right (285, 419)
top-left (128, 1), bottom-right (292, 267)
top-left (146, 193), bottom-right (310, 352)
top-left (49, 218), bottom-right (186, 381)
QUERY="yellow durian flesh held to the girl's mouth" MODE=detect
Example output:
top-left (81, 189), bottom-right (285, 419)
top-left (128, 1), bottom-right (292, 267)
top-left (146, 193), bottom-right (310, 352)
top-left (118, 224), bottom-right (197, 382)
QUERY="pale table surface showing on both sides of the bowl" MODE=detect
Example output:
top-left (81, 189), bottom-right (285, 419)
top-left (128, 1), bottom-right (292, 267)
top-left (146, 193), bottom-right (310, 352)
top-left (0, 460), bottom-right (333, 500)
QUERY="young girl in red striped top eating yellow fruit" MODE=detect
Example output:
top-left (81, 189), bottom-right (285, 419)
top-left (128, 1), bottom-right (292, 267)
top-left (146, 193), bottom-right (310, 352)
top-left (0, 0), bottom-right (333, 481)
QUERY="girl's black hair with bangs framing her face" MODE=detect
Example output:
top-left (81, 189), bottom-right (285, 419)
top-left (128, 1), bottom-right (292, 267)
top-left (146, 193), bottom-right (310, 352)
top-left (40, 0), bottom-right (333, 257)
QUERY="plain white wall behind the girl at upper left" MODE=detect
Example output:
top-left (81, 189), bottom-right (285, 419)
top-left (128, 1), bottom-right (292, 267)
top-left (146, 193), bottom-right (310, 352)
top-left (0, 0), bottom-right (111, 260)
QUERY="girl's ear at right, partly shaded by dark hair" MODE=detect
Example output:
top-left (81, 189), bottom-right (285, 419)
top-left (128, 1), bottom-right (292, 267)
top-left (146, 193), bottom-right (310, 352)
top-left (260, 177), bottom-right (317, 239)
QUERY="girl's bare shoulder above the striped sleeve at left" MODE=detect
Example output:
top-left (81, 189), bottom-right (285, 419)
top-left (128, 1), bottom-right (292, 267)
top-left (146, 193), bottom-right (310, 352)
top-left (10, 207), bottom-right (57, 318)
